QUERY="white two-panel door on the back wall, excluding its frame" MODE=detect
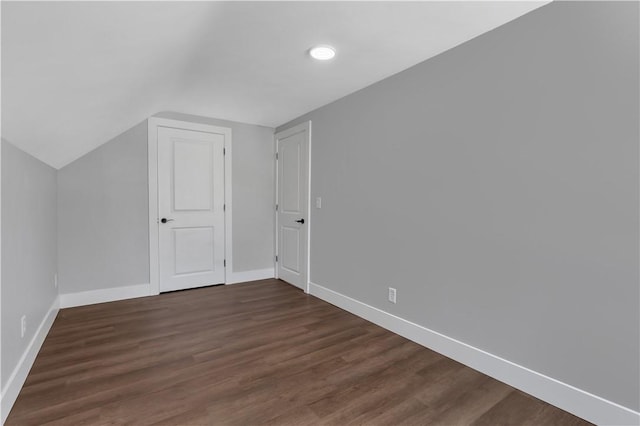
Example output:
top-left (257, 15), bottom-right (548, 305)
top-left (158, 127), bottom-right (225, 292)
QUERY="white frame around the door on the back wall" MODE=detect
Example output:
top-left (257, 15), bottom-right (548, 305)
top-left (147, 117), bottom-right (233, 295)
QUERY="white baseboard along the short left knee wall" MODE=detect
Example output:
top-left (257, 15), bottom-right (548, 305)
top-left (0, 297), bottom-right (59, 424)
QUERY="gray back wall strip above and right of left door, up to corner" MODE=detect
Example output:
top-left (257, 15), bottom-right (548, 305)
top-left (155, 112), bottom-right (274, 272)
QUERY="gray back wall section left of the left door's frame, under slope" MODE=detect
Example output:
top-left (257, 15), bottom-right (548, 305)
top-left (58, 120), bottom-right (149, 294)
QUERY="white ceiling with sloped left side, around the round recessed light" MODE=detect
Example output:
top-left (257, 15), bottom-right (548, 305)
top-left (2, 1), bottom-right (547, 168)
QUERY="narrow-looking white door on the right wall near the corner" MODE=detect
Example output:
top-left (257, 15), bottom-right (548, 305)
top-left (276, 124), bottom-right (309, 291)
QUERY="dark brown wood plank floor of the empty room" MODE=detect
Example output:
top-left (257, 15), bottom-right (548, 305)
top-left (6, 280), bottom-right (587, 426)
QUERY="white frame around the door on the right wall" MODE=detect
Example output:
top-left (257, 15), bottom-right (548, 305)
top-left (273, 121), bottom-right (311, 294)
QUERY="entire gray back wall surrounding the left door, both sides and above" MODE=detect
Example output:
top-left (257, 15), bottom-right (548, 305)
top-left (58, 112), bottom-right (274, 294)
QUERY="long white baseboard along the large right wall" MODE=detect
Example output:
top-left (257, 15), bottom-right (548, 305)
top-left (309, 283), bottom-right (640, 425)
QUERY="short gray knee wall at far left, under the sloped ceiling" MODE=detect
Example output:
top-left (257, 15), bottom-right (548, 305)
top-left (1, 139), bottom-right (58, 389)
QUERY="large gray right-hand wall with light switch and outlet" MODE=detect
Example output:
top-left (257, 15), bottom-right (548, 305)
top-left (278, 2), bottom-right (640, 410)
